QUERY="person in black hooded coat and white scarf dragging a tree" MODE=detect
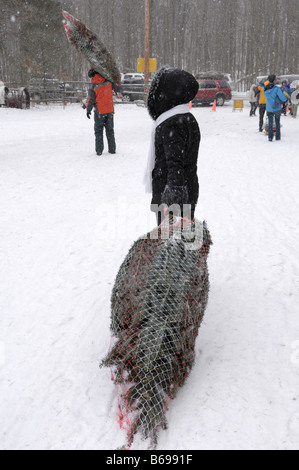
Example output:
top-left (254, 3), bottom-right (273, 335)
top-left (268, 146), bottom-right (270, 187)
top-left (145, 67), bottom-right (201, 225)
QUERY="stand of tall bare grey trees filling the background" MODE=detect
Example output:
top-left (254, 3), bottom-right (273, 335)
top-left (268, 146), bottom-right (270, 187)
top-left (0, 0), bottom-right (299, 88)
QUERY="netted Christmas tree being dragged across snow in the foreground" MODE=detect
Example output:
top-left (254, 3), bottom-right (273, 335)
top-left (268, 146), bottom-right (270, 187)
top-left (101, 219), bottom-right (212, 447)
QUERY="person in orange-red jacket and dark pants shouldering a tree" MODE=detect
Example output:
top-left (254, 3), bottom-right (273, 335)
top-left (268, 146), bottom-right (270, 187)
top-left (87, 69), bottom-right (116, 155)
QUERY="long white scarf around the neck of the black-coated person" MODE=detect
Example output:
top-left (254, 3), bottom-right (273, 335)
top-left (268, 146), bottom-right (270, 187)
top-left (143, 103), bottom-right (190, 193)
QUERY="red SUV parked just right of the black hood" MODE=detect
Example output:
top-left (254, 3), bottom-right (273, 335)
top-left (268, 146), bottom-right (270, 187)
top-left (193, 79), bottom-right (232, 106)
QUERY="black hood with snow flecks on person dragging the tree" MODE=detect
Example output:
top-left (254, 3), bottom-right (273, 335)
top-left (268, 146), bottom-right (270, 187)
top-left (147, 67), bottom-right (199, 121)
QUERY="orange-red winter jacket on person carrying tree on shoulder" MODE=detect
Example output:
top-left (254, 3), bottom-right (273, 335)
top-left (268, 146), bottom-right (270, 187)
top-left (87, 74), bottom-right (114, 114)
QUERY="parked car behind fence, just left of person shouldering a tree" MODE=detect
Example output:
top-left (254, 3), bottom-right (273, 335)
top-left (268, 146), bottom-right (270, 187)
top-left (28, 78), bottom-right (74, 101)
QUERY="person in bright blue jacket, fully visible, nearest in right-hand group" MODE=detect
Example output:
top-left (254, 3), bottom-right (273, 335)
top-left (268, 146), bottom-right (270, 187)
top-left (265, 75), bottom-right (288, 142)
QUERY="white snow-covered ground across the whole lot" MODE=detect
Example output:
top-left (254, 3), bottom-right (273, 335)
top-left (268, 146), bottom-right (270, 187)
top-left (0, 105), bottom-right (299, 450)
